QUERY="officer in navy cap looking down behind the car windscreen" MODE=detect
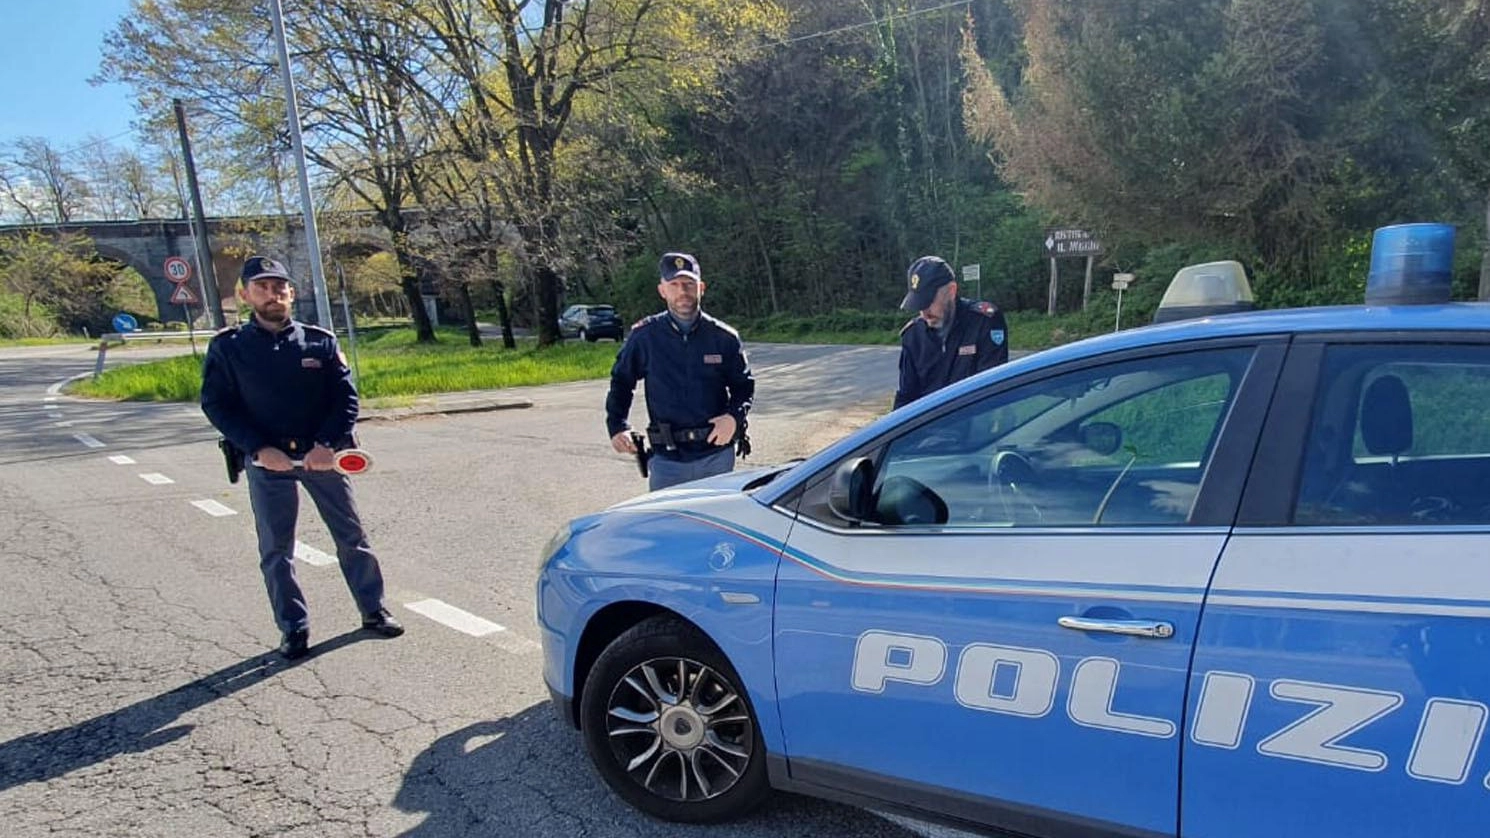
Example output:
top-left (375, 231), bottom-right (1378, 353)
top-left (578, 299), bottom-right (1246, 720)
top-left (895, 256), bottom-right (1009, 407)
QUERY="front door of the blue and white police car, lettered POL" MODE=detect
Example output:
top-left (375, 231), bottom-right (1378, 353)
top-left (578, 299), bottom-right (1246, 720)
top-left (775, 335), bottom-right (1283, 835)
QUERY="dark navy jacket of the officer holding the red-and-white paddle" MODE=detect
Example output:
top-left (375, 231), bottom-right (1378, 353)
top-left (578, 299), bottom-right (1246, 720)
top-left (201, 321), bottom-right (358, 459)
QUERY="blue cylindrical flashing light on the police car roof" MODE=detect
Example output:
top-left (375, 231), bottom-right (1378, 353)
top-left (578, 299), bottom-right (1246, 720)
top-left (1366, 224), bottom-right (1454, 306)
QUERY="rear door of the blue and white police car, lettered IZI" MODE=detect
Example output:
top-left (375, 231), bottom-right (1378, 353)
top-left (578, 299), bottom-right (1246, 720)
top-left (1182, 333), bottom-right (1490, 838)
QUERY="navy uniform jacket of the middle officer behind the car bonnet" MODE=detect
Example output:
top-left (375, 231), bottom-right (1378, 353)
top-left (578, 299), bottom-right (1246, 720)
top-left (605, 312), bottom-right (755, 459)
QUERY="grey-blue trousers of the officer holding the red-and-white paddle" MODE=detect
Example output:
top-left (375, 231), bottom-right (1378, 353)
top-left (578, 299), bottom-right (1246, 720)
top-left (244, 465), bottom-right (383, 632)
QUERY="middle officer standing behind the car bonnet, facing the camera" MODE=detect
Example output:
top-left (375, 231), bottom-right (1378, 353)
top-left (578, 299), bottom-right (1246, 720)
top-left (605, 253), bottom-right (755, 491)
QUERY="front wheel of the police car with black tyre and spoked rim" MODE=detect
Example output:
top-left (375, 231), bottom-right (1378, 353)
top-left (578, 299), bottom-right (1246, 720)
top-left (580, 616), bottom-right (770, 823)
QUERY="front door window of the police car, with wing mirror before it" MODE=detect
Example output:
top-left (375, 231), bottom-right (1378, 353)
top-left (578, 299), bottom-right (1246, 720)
top-left (852, 347), bottom-right (1253, 526)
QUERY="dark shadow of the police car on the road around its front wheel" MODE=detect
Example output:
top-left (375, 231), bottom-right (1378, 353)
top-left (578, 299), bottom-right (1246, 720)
top-left (393, 702), bottom-right (913, 838)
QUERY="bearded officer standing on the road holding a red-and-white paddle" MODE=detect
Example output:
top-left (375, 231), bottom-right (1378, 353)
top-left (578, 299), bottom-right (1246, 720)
top-left (201, 256), bottom-right (404, 661)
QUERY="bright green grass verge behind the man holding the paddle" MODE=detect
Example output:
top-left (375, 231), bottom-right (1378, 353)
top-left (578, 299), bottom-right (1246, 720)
top-left (72, 328), bottom-right (617, 404)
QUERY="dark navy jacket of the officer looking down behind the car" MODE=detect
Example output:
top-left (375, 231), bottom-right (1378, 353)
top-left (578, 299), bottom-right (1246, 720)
top-left (895, 297), bottom-right (1009, 407)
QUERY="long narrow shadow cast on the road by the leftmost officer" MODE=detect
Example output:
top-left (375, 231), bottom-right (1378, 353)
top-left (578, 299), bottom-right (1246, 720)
top-left (0, 631), bottom-right (371, 792)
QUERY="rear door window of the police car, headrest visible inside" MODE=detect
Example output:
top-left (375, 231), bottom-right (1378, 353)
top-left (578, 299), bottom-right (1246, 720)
top-left (1293, 344), bottom-right (1490, 526)
